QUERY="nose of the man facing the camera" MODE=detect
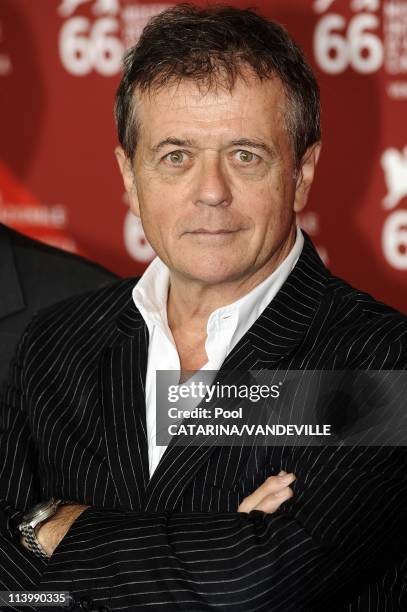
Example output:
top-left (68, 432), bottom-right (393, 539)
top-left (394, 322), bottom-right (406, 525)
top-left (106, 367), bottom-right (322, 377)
top-left (194, 153), bottom-right (232, 207)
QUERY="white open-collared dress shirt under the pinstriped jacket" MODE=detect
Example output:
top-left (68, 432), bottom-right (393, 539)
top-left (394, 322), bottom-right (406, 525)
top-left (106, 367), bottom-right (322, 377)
top-left (133, 226), bottom-right (304, 478)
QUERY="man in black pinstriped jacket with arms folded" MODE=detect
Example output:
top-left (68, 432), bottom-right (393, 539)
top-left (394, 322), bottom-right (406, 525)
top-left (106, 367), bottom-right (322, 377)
top-left (0, 5), bottom-right (407, 612)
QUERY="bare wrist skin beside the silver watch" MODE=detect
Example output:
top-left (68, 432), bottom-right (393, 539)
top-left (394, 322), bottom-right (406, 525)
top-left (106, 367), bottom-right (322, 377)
top-left (21, 504), bottom-right (89, 557)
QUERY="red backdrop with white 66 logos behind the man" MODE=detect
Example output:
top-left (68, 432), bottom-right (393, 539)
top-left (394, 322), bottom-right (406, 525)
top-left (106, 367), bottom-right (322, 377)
top-left (0, 0), bottom-right (407, 312)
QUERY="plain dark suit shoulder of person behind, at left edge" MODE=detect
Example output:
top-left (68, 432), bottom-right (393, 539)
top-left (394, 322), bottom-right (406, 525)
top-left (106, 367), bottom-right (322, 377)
top-left (0, 223), bottom-right (117, 387)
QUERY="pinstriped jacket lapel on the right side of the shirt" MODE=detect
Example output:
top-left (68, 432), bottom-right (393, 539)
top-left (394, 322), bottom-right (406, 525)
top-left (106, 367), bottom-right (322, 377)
top-left (144, 234), bottom-right (329, 512)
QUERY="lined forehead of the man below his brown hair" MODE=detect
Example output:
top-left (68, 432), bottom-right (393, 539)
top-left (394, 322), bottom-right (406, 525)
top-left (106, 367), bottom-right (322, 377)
top-left (135, 75), bottom-right (286, 146)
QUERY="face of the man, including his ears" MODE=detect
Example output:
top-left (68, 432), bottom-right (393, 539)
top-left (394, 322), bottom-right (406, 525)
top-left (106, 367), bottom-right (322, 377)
top-left (117, 75), bottom-right (318, 284)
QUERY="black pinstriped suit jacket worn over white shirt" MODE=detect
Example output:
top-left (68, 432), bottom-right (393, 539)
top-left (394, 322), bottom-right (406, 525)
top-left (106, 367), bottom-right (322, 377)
top-left (0, 236), bottom-right (407, 612)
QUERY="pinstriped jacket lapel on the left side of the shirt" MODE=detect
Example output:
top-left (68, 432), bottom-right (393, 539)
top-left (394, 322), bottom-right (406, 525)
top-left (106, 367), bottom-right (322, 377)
top-left (99, 304), bottom-right (149, 511)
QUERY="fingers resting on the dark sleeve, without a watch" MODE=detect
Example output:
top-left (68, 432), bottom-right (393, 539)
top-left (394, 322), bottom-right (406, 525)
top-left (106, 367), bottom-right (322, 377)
top-left (237, 470), bottom-right (295, 514)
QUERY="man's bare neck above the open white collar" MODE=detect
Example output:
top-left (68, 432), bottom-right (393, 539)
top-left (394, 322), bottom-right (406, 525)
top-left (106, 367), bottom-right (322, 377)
top-left (167, 227), bottom-right (296, 334)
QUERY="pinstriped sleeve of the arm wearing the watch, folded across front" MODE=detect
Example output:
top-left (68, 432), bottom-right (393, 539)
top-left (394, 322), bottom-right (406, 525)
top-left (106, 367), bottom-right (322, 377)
top-left (34, 343), bottom-right (407, 612)
